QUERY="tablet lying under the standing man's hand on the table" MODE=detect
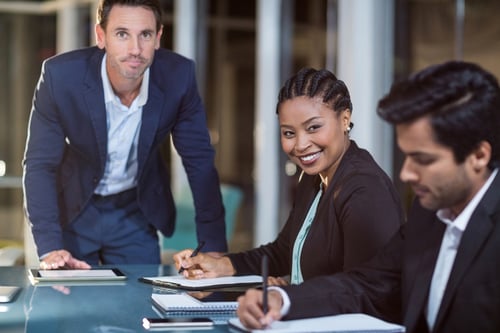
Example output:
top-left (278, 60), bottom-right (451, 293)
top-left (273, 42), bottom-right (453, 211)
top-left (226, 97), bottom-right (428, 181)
top-left (28, 268), bottom-right (127, 282)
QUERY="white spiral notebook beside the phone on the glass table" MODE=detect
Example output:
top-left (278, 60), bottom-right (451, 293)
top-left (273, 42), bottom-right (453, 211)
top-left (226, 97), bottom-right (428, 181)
top-left (151, 293), bottom-right (238, 314)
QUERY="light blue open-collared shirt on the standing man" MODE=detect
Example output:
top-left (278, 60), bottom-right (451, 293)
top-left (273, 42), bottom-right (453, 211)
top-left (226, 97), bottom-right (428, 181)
top-left (95, 55), bottom-right (149, 195)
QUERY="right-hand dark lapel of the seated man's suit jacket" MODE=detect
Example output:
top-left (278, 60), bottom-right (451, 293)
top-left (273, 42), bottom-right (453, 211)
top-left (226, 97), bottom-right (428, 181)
top-left (434, 175), bottom-right (500, 330)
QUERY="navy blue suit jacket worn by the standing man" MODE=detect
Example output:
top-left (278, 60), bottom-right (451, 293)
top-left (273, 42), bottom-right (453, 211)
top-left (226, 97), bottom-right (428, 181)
top-left (23, 47), bottom-right (227, 255)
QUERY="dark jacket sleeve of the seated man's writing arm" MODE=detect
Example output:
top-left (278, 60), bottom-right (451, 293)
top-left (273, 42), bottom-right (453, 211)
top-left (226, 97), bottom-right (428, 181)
top-left (284, 225), bottom-right (405, 322)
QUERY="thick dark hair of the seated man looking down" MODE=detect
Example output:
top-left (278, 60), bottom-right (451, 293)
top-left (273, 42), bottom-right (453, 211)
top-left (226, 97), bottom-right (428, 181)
top-left (377, 61), bottom-right (500, 168)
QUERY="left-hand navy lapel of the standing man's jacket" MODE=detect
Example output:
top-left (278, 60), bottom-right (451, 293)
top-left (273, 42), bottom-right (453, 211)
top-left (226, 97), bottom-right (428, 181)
top-left (83, 48), bottom-right (108, 168)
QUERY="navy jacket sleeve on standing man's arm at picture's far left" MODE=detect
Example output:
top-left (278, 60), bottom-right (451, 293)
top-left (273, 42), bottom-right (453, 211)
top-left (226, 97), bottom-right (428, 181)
top-left (23, 62), bottom-right (64, 255)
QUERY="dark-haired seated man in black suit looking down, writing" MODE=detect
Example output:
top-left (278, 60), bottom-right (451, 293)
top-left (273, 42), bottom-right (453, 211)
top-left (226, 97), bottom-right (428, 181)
top-left (238, 61), bottom-right (500, 333)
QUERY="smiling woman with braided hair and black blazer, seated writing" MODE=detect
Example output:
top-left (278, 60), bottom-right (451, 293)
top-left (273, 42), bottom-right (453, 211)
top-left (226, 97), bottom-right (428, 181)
top-left (174, 68), bottom-right (403, 285)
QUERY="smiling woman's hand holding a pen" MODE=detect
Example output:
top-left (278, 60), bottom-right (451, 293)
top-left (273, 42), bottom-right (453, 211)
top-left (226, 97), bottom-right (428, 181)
top-left (173, 249), bottom-right (235, 279)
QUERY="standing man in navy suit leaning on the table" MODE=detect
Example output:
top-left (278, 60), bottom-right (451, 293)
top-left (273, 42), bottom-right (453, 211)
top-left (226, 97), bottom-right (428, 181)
top-left (23, 0), bottom-right (227, 269)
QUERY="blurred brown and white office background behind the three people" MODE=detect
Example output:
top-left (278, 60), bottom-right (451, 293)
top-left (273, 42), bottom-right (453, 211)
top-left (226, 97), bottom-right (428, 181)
top-left (0, 0), bottom-right (500, 264)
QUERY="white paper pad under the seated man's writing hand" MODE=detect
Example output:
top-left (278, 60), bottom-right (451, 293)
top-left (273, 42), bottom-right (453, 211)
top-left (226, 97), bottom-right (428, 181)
top-left (229, 313), bottom-right (405, 333)
